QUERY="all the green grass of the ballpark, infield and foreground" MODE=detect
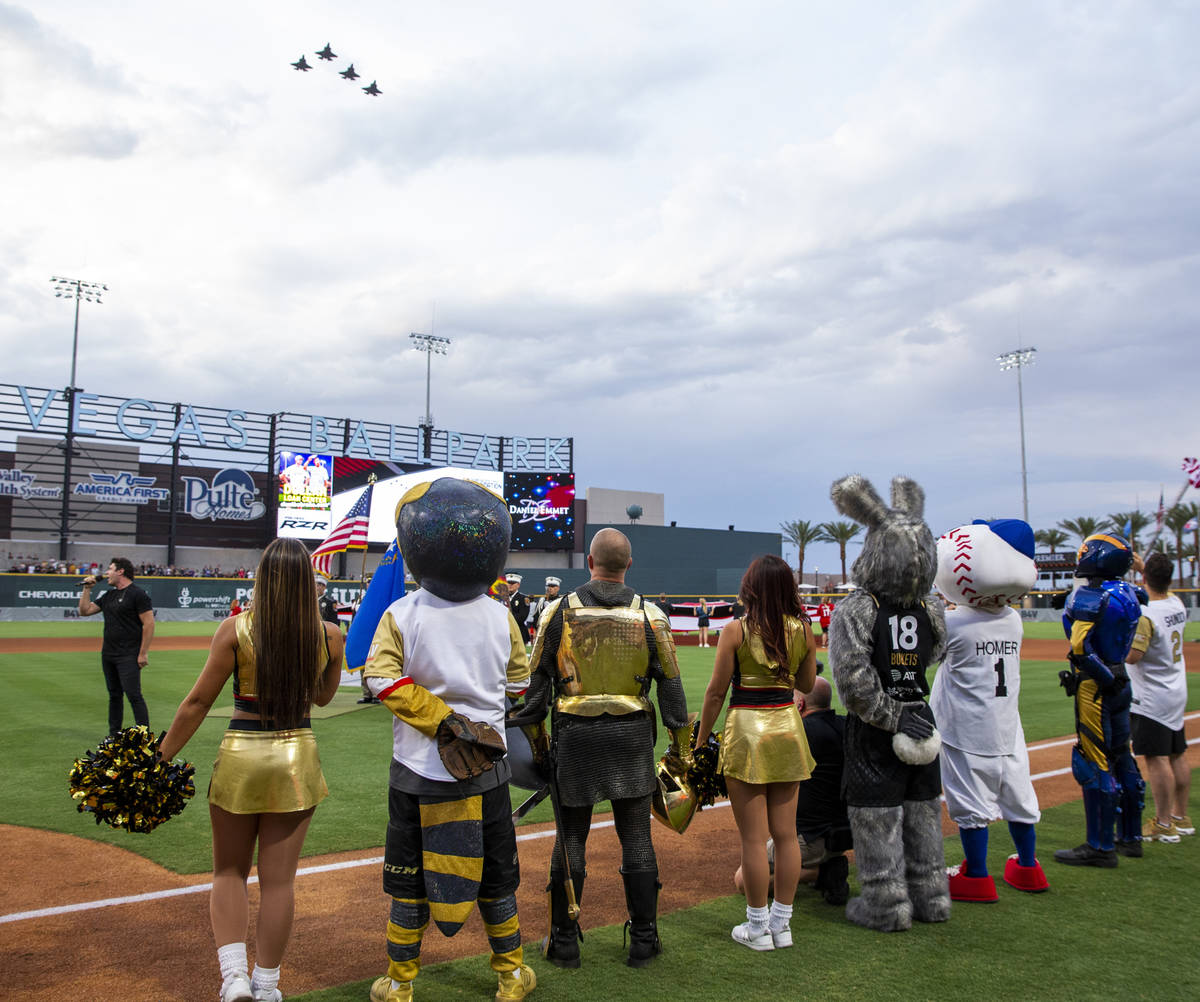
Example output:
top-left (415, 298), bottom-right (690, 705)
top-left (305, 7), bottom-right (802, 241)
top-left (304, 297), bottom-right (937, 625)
top-left (0, 623), bottom-right (1200, 1002)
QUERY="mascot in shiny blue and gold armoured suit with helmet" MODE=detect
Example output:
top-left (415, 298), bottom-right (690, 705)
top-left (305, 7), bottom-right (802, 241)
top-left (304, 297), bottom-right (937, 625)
top-left (1054, 533), bottom-right (1146, 868)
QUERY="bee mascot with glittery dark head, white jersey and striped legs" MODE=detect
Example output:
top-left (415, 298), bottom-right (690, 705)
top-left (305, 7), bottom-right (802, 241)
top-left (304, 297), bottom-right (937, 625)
top-left (364, 478), bottom-right (536, 1002)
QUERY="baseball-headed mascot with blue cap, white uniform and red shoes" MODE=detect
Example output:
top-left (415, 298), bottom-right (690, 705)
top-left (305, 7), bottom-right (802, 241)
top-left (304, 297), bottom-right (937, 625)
top-left (929, 518), bottom-right (1049, 901)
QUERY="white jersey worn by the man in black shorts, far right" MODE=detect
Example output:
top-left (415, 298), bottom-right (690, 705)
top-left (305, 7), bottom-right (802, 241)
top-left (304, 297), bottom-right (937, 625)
top-left (1126, 595), bottom-right (1188, 731)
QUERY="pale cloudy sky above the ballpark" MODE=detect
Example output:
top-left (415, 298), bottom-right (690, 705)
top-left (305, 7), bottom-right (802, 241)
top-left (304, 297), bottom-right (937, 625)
top-left (0, 0), bottom-right (1200, 569)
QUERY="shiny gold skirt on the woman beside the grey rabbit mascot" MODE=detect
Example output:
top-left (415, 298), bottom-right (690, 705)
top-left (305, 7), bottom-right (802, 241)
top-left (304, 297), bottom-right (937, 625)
top-left (716, 704), bottom-right (816, 782)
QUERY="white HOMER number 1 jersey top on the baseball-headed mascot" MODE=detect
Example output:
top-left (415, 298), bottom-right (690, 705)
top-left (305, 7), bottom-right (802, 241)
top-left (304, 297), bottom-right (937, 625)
top-left (929, 606), bottom-right (1025, 755)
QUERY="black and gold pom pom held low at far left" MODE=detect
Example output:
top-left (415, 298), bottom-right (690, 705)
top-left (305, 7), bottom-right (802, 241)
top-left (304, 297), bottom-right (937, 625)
top-left (67, 726), bottom-right (196, 833)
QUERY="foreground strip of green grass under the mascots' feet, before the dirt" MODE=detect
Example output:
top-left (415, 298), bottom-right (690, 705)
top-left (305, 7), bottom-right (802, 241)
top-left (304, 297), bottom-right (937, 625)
top-left (283, 797), bottom-right (1200, 1002)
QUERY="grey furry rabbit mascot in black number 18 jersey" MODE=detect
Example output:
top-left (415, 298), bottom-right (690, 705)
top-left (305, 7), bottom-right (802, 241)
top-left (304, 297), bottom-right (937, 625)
top-left (829, 475), bottom-right (950, 932)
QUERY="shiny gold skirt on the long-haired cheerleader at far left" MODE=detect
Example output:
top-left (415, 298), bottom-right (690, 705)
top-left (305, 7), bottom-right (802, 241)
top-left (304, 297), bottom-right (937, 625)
top-left (209, 727), bottom-right (329, 814)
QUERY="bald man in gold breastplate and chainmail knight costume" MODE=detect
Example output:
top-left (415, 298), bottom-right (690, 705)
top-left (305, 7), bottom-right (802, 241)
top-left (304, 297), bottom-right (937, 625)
top-left (515, 529), bottom-right (691, 967)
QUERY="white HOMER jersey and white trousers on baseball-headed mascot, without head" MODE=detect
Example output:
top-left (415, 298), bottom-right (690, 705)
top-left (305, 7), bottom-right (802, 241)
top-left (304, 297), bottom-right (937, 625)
top-left (929, 606), bottom-right (1042, 828)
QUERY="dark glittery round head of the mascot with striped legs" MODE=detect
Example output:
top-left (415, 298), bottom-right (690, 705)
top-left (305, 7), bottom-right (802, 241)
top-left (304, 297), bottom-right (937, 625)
top-left (396, 476), bottom-right (512, 602)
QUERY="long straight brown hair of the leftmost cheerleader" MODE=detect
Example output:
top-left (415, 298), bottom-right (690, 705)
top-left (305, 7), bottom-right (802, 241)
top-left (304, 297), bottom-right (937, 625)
top-left (251, 539), bottom-right (325, 731)
